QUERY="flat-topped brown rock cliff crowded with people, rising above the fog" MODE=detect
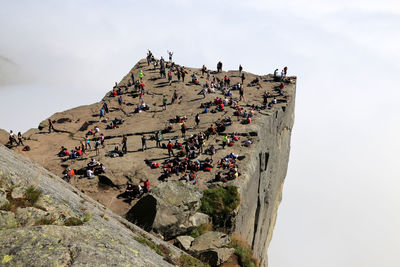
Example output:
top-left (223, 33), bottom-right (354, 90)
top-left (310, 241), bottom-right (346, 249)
top-left (3, 57), bottom-right (296, 266)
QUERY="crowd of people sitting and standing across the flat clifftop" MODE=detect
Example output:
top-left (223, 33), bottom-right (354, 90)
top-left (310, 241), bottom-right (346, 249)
top-left (3, 51), bottom-right (287, 209)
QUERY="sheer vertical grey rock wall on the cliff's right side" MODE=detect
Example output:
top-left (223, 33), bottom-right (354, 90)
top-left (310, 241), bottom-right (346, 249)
top-left (234, 85), bottom-right (295, 266)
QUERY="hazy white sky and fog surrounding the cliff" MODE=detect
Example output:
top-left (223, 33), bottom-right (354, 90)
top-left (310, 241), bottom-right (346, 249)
top-left (0, 0), bottom-right (400, 267)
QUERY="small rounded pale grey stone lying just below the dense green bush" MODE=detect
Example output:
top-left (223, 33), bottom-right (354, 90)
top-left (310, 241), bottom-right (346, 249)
top-left (190, 232), bottom-right (231, 253)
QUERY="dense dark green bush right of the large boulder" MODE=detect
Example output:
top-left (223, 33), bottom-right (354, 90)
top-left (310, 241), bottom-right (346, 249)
top-left (201, 186), bottom-right (240, 221)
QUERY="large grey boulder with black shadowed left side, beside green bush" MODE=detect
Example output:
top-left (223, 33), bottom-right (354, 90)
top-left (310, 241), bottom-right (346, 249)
top-left (126, 181), bottom-right (206, 240)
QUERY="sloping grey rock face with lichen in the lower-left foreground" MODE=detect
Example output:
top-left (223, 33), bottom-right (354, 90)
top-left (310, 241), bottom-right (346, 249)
top-left (0, 145), bottom-right (180, 266)
